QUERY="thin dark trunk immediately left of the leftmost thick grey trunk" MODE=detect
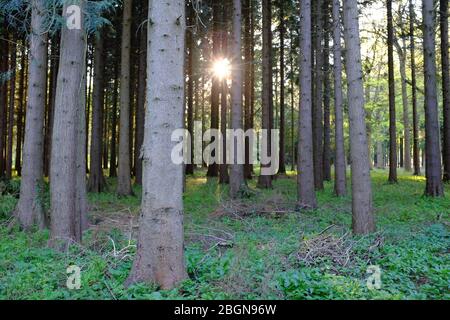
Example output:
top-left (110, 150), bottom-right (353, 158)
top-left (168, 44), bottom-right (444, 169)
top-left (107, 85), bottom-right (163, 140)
top-left (15, 40), bottom-right (27, 177)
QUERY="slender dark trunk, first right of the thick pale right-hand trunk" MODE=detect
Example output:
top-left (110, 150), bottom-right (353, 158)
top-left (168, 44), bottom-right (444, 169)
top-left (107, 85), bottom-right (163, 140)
top-left (386, 0), bottom-right (397, 183)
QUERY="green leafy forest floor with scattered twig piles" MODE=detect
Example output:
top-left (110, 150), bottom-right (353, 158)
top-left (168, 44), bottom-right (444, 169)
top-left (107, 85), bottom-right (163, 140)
top-left (0, 170), bottom-right (450, 299)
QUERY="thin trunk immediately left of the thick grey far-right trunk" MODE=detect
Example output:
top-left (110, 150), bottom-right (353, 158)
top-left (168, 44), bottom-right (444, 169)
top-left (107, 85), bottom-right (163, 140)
top-left (409, 0), bottom-right (420, 176)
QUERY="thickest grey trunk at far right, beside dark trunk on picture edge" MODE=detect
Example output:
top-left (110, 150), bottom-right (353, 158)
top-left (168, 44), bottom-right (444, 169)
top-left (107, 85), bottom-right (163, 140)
top-left (422, 0), bottom-right (444, 197)
